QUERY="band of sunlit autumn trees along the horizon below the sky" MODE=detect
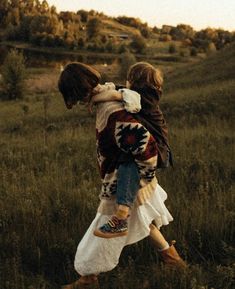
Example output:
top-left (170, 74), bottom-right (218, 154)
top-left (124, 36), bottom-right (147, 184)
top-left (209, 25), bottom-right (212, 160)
top-left (0, 0), bottom-right (235, 53)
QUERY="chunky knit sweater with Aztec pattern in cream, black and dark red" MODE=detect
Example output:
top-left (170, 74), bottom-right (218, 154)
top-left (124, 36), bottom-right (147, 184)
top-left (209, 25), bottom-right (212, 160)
top-left (96, 102), bottom-right (158, 200)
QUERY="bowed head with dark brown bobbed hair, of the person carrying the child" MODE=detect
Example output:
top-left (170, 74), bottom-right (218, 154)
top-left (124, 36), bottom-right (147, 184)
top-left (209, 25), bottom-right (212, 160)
top-left (58, 62), bottom-right (100, 105)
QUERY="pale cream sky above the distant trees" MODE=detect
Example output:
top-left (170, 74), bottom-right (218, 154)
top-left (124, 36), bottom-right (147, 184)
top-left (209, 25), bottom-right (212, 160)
top-left (47, 0), bottom-right (235, 31)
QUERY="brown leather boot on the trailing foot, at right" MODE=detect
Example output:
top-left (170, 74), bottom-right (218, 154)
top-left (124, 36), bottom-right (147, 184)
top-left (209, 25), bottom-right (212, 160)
top-left (159, 241), bottom-right (187, 269)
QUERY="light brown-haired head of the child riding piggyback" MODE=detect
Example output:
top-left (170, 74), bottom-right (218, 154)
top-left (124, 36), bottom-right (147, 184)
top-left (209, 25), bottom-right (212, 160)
top-left (127, 62), bottom-right (163, 94)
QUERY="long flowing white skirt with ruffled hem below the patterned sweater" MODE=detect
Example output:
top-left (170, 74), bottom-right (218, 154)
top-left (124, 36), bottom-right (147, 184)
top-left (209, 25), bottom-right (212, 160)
top-left (74, 184), bottom-right (173, 276)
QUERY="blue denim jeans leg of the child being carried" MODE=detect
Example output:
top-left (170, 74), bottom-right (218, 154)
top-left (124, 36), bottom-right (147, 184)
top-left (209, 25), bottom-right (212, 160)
top-left (116, 161), bottom-right (140, 207)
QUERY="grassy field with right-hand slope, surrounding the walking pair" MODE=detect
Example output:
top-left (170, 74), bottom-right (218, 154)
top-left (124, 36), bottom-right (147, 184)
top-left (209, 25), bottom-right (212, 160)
top-left (0, 47), bottom-right (235, 289)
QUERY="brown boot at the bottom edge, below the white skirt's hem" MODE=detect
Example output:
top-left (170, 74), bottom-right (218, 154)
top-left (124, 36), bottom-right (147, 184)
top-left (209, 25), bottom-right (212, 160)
top-left (61, 275), bottom-right (100, 289)
